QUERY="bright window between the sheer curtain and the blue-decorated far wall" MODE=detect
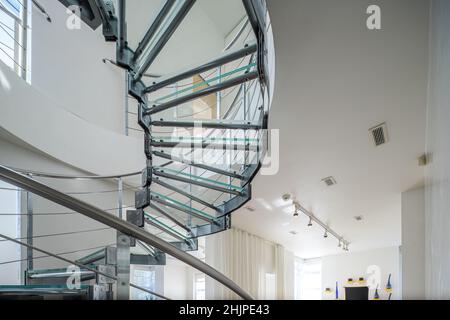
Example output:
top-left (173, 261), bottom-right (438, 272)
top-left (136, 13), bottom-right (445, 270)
top-left (295, 259), bottom-right (322, 300)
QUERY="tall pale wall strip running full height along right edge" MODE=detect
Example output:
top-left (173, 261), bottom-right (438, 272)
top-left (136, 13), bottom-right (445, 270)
top-left (425, 0), bottom-right (450, 299)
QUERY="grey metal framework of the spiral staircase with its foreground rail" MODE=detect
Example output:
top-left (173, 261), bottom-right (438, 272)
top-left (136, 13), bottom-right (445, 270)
top-left (0, 0), bottom-right (269, 299)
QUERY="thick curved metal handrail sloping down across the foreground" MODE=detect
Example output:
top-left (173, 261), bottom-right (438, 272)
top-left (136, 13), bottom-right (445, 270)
top-left (0, 166), bottom-right (253, 300)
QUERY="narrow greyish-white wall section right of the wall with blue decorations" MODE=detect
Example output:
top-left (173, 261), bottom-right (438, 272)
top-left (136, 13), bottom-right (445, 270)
top-left (401, 188), bottom-right (425, 299)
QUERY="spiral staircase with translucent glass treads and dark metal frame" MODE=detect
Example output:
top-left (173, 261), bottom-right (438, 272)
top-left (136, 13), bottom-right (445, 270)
top-left (0, 0), bottom-right (270, 299)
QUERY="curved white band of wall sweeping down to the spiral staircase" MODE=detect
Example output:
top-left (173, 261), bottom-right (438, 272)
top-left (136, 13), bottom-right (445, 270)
top-left (0, 63), bottom-right (145, 175)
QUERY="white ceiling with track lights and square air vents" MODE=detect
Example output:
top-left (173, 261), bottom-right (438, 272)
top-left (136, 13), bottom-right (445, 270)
top-left (233, 0), bottom-right (428, 258)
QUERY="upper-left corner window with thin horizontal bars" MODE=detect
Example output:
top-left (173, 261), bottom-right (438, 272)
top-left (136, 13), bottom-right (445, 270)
top-left (0, 0), bottom-right (30, 79)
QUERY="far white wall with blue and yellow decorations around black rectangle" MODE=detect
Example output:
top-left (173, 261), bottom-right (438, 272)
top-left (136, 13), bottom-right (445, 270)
top-left (322, 248), bottom-right (401, 299)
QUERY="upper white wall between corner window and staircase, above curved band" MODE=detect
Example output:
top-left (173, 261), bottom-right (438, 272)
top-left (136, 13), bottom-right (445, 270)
top-left (31, 0), bottom-right (125, 133)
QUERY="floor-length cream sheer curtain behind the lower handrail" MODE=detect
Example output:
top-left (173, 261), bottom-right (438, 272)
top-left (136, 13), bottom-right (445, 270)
top-left (206, 228), bottom-right (285, 300)
